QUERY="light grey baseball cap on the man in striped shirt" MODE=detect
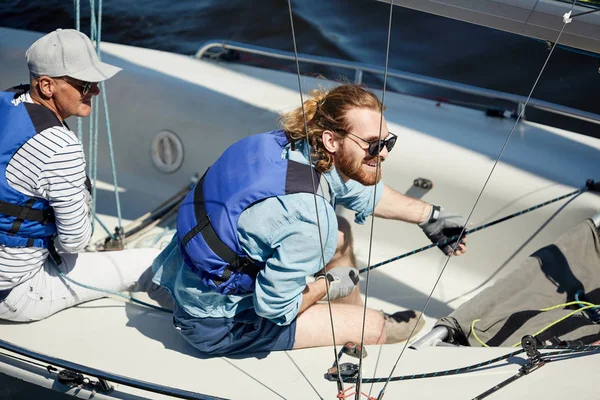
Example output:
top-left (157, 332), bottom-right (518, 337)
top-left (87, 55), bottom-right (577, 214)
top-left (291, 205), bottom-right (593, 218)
top-left (25, 29), bottom-right (121, 82)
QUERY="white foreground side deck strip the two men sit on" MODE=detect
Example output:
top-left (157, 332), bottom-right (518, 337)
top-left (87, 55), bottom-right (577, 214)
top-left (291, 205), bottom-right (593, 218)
top-left (0, 299), bottom-right (600, 400)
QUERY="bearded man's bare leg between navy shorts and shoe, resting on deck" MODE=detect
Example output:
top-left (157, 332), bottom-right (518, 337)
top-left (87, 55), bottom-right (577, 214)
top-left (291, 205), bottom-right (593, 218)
top-left (294, 303), bottom-right (386, 349)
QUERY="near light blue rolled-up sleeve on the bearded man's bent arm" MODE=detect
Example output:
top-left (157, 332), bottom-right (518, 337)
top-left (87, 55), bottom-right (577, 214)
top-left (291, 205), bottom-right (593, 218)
top-left (238, 193), bottom-right (337, 325)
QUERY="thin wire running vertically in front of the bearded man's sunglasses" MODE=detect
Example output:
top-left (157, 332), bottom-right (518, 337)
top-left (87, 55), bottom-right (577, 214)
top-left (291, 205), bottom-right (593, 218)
top-left (355, 0), bottom-right (394, 400)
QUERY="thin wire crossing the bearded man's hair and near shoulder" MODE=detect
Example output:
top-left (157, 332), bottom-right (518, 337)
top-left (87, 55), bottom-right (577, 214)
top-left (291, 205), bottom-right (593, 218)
top-left (288, 0), bottom-right (344, 391)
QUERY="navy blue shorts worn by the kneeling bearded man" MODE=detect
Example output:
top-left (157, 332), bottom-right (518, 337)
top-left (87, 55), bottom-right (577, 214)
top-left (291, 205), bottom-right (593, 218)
top-left (173, 306), bottom-right (296, 357)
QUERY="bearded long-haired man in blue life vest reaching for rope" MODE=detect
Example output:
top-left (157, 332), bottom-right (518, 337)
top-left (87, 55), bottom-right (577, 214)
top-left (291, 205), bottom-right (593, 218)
top-left (154, 85), bottom-right (466, 356)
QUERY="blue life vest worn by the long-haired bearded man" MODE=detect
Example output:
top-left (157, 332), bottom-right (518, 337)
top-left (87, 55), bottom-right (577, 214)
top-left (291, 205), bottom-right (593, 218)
top-left (177, 131), bottom-right (330, 294)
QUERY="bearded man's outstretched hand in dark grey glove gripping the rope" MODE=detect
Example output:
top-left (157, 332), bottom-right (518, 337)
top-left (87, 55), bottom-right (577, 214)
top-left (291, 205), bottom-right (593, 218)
top-left (419, 206), bottom-right (466, 256)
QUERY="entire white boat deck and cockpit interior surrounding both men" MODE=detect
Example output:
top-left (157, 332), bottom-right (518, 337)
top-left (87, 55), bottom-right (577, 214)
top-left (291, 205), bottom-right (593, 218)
top-left (0, 28), bottom-right (600, 400)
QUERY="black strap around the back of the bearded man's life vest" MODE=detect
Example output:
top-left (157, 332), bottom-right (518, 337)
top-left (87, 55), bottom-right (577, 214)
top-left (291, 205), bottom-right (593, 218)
top-left (181, 176), bottom-right (260, 286)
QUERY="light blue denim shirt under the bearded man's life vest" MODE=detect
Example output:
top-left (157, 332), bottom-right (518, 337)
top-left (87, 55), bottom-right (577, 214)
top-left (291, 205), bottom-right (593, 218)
top-left (152, 142), bottom-right (383, 325)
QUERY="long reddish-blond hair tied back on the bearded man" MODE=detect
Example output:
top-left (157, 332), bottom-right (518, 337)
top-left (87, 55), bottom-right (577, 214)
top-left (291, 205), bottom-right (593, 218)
top-left (279, 84), bottom-right (382, 172)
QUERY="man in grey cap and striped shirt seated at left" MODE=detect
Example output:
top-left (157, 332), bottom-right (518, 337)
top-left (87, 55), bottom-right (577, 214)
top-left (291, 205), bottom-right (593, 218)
top-left (0, 29), bottom-right (162, 321)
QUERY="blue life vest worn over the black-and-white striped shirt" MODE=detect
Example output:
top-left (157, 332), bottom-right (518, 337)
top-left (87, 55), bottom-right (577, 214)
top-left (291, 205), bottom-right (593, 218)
top-left (0, 86), bottom-right (62, 248)
